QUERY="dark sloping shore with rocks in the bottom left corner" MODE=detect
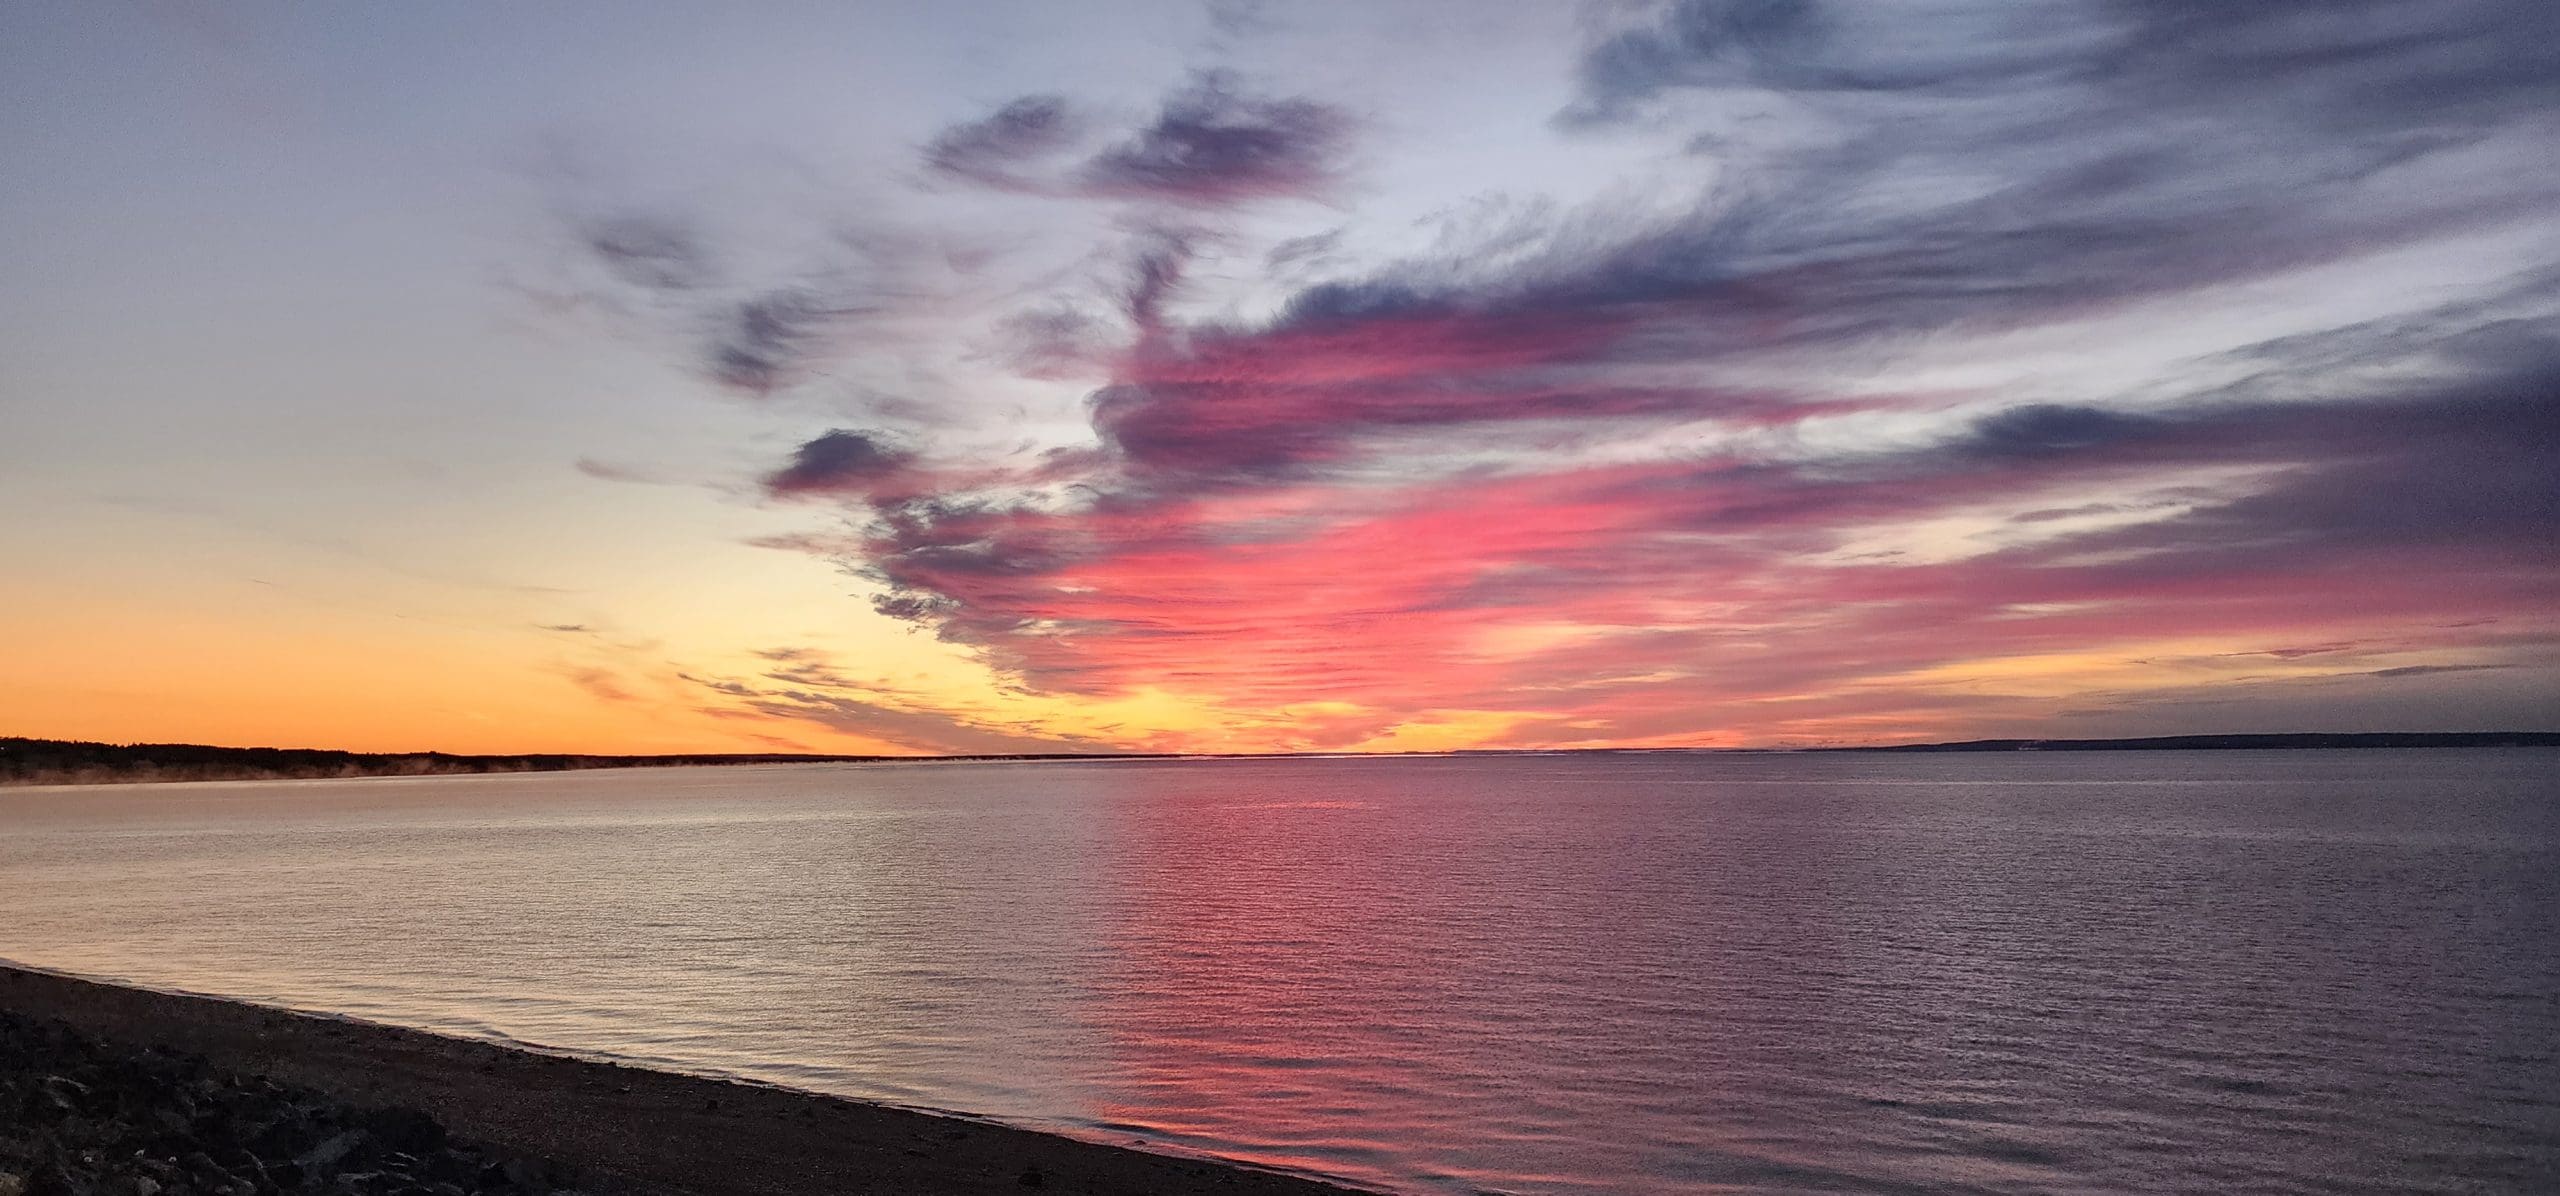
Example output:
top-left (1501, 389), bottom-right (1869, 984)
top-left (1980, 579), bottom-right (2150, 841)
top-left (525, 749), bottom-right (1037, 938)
top-left (0, 968), bottom-right (1347, 1196)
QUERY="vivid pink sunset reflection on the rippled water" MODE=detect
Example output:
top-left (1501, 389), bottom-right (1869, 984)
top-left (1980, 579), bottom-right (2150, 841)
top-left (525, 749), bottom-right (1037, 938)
top-left (1070, 773), bottom-right (1730, 1191)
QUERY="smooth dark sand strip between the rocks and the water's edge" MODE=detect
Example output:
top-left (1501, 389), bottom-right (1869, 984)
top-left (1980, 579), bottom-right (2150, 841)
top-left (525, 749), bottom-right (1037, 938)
top-left (0, 966), bottom-right (1347, 1196)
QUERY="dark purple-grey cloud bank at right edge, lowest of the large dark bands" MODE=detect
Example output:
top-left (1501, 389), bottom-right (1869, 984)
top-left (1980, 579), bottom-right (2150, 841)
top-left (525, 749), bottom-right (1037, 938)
top-left (1710, 335), bottom-right (2560, 565)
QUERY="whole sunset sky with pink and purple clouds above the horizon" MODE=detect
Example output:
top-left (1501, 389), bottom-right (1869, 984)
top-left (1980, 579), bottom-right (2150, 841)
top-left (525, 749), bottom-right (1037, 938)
top-left (0, 0), bottom-right (2560, 753)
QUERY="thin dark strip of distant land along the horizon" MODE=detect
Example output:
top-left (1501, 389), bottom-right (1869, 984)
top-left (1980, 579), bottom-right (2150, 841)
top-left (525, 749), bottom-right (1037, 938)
top-left (0, 730), bottom-right (2560, 784)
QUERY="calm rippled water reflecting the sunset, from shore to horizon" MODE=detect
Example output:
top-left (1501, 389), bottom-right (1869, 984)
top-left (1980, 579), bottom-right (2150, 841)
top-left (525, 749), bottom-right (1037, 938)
top-left (0, 750), bottom-right (2560, 1193)
